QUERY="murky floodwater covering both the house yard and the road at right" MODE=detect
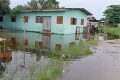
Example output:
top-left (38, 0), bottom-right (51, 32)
top-left (0, 31), bottom-right (120, 80)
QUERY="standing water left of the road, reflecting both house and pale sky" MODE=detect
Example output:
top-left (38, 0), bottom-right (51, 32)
top-left (0, 32), bottom-right (89, 80)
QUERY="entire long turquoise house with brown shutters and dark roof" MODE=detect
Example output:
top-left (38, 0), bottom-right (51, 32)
top-left (0, 8), bottom-right (91, 34)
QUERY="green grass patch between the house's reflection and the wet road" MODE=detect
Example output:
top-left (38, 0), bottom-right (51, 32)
top-left (62, 40), bottom-right (98, 59)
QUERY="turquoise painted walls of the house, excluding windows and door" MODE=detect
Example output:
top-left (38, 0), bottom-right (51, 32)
top-left (0, 10), bottom-right (87, 34)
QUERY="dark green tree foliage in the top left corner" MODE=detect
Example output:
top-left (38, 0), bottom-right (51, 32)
top-left (0, 0), bottom-right (10, 15)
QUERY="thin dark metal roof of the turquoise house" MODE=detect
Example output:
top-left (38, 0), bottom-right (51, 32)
top-left (22, 8), bottom-right (92, 15)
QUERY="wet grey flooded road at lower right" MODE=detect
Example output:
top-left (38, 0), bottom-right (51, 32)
top-left (61, 40), bottom-right (120, 80)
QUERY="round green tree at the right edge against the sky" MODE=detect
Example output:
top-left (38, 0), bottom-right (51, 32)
top-left (104, 5), bottom-right (120, 27)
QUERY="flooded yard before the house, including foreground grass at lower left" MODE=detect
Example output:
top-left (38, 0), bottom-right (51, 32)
top-left (0, 31), bottom-right (89, 80)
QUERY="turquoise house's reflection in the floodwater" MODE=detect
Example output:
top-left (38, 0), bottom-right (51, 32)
top-left (0, 32), bottom-right (86, 51)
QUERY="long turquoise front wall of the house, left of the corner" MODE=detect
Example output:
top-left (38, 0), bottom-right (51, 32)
top-left (3, 12), bottom-right (64, 34)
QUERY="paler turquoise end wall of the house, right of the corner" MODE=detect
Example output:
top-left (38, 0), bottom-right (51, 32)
top-left (65, 10), bottom-right (87, 34)
